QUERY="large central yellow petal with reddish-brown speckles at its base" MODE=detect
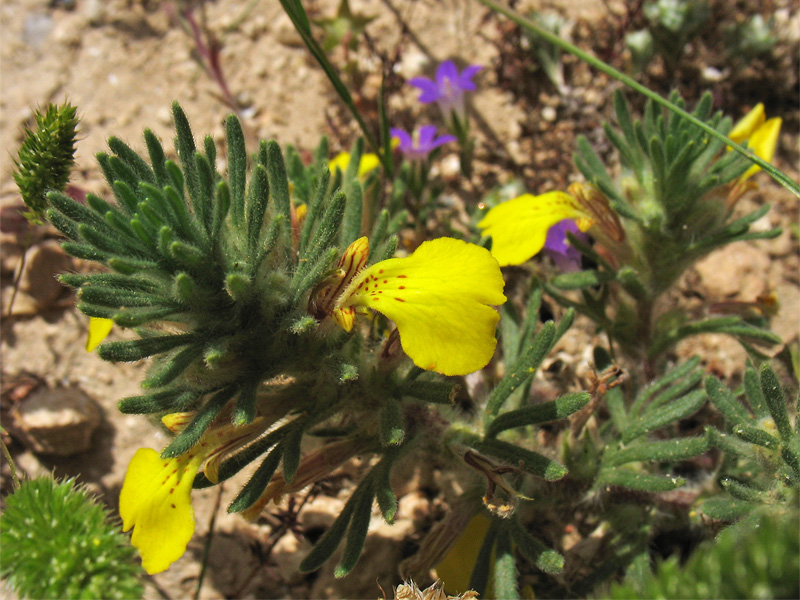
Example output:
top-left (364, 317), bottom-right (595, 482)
top-left (336, 238), bottom-right (506, 375)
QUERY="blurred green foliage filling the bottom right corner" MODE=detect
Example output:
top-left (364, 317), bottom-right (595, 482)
top-left (599, 512), bottom-right (800, 599)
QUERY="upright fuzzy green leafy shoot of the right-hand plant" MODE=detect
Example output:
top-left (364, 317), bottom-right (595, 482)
top-left (544, 92), bottom-right (780, 371)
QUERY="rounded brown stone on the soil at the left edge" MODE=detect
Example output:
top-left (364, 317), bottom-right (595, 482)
top-left (11, 388), bottom-right (100, 456)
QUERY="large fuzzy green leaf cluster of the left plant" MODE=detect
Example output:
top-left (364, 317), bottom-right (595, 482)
top-left (46, 104), bottom-right (422, 576)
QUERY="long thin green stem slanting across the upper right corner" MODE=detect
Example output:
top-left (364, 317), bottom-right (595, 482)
top-left (478, 0), bottom-right (800, 198)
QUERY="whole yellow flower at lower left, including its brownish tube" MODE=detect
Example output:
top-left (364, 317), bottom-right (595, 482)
top-left (119, 413), bottom-right (263, 575)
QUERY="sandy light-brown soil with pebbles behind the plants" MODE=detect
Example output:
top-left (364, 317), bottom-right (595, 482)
top-left (0, 0), bottom-right (800, 599)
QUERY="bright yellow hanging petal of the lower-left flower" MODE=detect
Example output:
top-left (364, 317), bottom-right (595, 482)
top-left (119, 448), bottom-right (203, 575)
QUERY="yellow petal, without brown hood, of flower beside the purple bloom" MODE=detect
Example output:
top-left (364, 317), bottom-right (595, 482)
top-left (478, 192), bottom-right (593, 267)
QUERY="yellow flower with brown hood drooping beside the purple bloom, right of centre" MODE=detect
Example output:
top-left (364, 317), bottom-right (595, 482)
top-left (478, 183), bottom-right (625, 267)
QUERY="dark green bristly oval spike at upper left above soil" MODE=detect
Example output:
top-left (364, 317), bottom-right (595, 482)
top-left (14, 102), bottom-right (78, 220)
